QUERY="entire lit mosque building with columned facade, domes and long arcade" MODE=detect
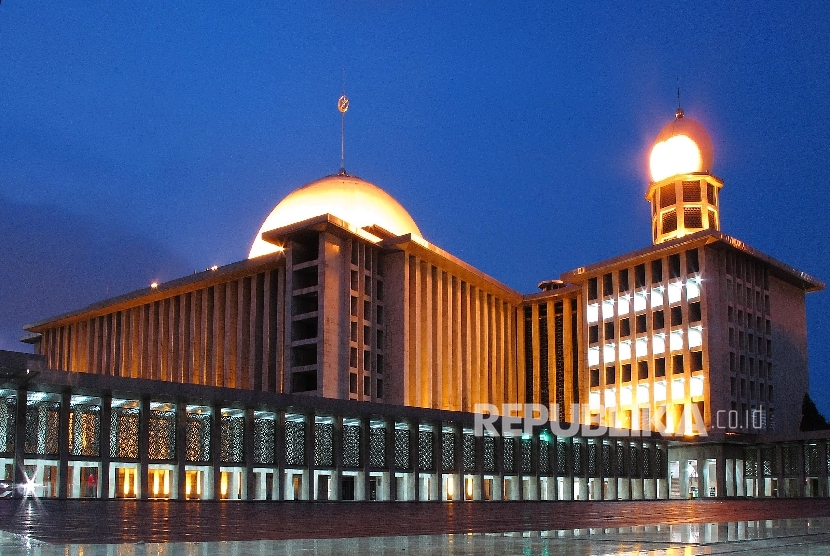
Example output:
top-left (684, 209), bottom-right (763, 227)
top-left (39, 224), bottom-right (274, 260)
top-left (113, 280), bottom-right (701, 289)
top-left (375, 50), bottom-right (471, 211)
top-left (0, 102), bottom-right (830, 500)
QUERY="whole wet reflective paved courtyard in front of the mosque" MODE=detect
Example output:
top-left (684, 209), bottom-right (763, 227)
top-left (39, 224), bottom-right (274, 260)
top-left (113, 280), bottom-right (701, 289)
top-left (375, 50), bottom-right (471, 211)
top-left (0, 500), bottom-right (830, 556)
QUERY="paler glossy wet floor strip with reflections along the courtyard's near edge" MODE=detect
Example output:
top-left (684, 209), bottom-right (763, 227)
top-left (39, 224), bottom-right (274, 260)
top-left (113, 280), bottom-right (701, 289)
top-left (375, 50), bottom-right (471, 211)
top-left (0, 518), bottom-right (830, 556)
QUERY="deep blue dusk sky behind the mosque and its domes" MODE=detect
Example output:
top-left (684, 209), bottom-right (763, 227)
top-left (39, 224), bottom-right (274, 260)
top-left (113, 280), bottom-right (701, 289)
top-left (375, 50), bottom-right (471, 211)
top-left (0, 0), bottom-right (830, 415)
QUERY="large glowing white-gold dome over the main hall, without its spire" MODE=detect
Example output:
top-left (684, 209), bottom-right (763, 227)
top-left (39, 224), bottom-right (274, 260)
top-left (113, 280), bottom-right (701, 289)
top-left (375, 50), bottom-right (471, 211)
top-left (248, 174), bottom-right (421, 259)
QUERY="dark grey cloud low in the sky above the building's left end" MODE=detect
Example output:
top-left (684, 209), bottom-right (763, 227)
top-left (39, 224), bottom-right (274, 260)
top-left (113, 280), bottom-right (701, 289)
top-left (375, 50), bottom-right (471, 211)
top-left (0, 198), bottom-right (191, 351)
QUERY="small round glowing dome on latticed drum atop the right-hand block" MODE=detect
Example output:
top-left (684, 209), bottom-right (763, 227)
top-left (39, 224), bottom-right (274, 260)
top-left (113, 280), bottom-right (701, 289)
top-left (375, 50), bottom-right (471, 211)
top-left (646, 104), bottom-right (723, 245)
